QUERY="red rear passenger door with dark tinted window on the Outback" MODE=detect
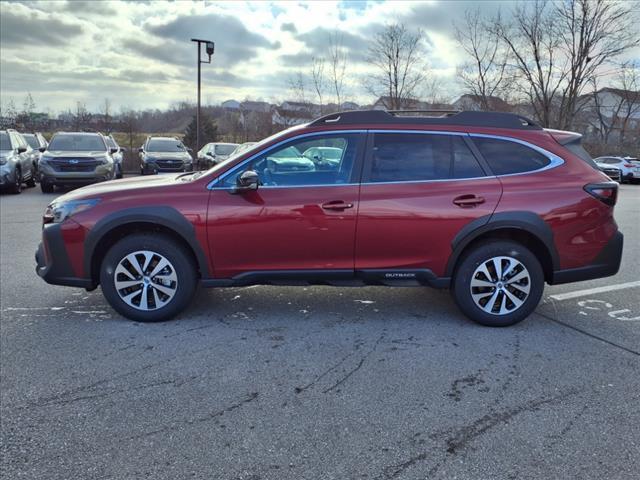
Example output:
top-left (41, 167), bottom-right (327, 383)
top-left (355, 131), bottom-right (502, 276)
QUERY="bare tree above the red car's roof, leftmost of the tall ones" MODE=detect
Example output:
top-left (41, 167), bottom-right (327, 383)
top-left (366, 23), bottom-right (425, 109)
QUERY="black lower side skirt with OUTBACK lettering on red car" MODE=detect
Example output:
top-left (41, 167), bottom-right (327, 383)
top-left (200, 269), bottom-right (451, 288)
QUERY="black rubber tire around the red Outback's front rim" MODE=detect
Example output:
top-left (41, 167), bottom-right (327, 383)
top-left (100, 233), bottom-right (197, 322)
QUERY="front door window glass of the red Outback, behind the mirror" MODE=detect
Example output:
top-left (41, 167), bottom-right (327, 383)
top-left (221, 133), bottom-right (361, 187)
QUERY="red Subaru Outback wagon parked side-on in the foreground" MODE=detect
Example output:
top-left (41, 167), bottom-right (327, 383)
top-left (36, 111), bottom-right (622, 326)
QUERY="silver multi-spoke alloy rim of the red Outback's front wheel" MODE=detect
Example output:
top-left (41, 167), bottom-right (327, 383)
top-left (113, 250), bottom-right (178, 311)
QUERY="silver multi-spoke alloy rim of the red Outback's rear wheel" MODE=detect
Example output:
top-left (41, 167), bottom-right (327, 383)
top-left (470, 256), bottom-right (531, 315)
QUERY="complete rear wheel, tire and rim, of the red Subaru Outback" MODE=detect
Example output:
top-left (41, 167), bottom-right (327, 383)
top-left (453, 240), bottom-right (544, 327)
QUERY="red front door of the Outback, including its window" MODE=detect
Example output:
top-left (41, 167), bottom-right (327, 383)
top-left (207, 132), bottom-right (364, 278)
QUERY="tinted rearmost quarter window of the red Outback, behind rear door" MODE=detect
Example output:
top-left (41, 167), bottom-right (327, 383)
top-left (473, 137), bottom-right (551, 175)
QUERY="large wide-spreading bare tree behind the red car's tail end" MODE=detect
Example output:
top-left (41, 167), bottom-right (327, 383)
top-left (491, 0), bottom-right (640, 129)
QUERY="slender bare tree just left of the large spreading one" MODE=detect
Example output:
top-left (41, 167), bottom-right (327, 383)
top-left (455, 8), bottom-right (508, 110)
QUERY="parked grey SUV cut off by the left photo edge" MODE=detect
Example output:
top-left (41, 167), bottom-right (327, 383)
top-left (0, 130), bottom-right (36, 193)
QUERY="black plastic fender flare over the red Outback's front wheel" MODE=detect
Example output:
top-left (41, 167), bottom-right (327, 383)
top-left (83, 206), bottom-right (209, 278)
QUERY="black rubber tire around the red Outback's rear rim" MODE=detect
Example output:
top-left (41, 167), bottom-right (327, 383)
top-left (452, 240), bottom-right (544, 327)
